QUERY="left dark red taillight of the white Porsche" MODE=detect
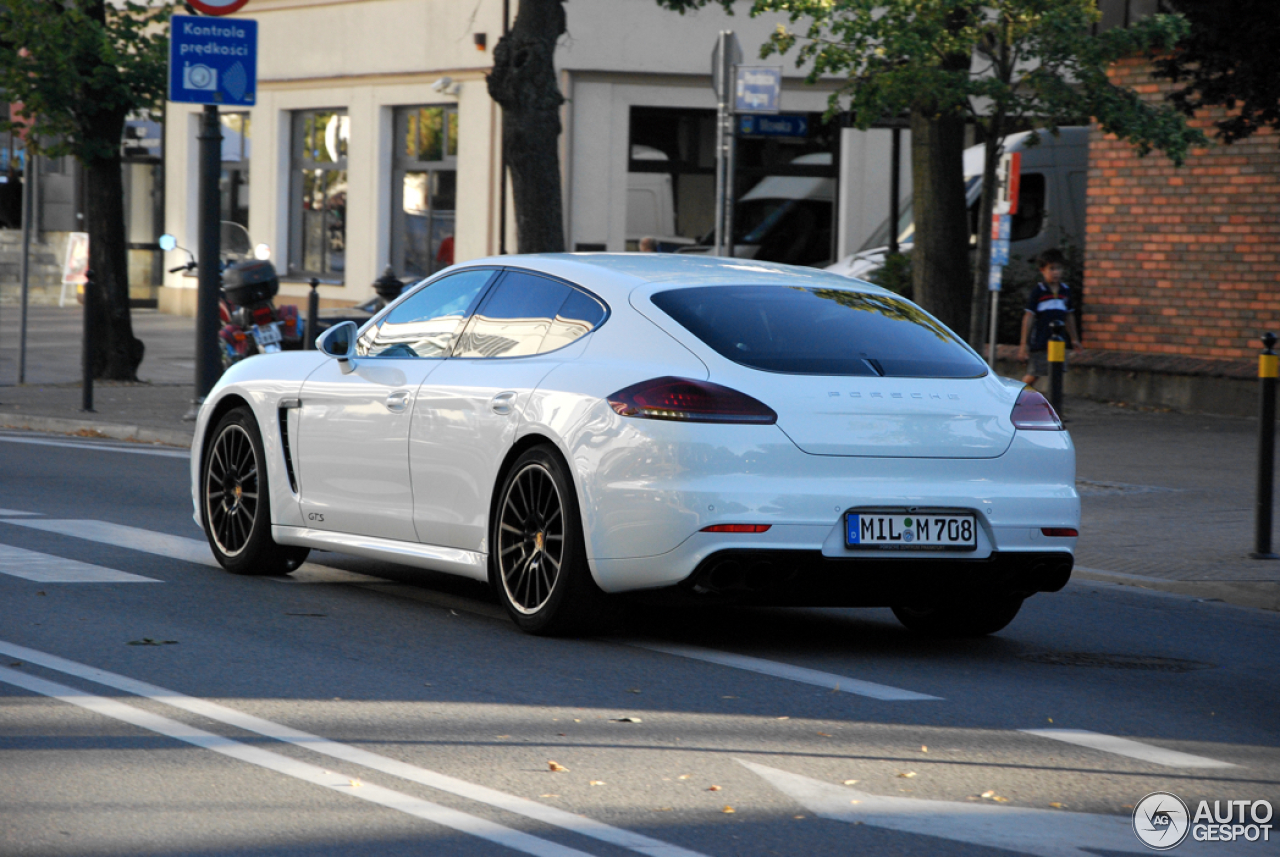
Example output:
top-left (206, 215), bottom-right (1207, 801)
top-left (608, 377), bottom-right (778, 425)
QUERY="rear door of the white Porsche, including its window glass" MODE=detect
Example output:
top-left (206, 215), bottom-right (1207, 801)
top-left (410, 270), bottom-right (605, 553)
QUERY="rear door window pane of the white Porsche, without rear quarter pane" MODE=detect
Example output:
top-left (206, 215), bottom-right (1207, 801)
top-left (454, 271), bottom-right (572, 357)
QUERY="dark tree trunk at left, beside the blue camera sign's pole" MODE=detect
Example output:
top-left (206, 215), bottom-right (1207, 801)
top-left (84, 145), bottom-right (145, 381)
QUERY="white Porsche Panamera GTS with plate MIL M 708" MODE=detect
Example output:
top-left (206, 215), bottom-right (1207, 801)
top-left (191, 253), bottom-right (1080, 634)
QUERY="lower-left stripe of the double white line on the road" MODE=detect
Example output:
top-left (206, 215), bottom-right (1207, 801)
top-left (0, 666), bottom-right (591, 857)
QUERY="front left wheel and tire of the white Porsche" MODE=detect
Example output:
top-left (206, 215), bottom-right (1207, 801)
top-left (200, 407), bottom-right (310, 574)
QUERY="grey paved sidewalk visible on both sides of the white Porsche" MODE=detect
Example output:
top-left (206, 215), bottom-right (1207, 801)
top-left (0, 307), bottom-right (1280, 610)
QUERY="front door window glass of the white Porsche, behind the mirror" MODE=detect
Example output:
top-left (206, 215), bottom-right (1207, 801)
top-left (366, 270), bottom-right (494, 357)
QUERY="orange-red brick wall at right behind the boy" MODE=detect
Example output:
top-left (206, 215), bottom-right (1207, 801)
top-left (1082, 60), bottom-right (1280, 358)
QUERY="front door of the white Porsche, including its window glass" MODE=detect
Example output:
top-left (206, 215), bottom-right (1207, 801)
top-left (298, 269), bottom-right (497, 541)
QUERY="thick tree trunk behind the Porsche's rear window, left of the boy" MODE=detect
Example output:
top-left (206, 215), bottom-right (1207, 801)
top-left (911, 110), bottom-right (970, 336)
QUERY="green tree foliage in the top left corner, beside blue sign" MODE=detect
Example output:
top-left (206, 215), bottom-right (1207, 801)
top-left (0, 0), bottom-right (173, 162)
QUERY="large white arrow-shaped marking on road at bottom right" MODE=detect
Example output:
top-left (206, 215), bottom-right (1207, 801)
top-left (737, 760), bottom-right (1253, 857)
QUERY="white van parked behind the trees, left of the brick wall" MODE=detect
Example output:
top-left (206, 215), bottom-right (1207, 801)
top-left (827, 127), bottom-right (1089, 278)
